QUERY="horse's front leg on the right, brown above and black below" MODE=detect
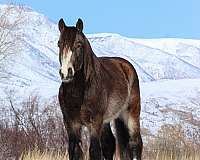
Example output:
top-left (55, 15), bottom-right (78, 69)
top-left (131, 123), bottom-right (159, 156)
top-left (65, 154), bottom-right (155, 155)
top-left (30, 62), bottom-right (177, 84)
top-left (89, 124), bottom-right (103, 160)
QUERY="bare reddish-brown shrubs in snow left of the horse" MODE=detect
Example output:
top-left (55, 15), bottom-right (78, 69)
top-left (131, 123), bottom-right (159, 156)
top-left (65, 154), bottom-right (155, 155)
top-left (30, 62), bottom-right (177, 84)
top-left (0, 96), bottom-right (67, 159)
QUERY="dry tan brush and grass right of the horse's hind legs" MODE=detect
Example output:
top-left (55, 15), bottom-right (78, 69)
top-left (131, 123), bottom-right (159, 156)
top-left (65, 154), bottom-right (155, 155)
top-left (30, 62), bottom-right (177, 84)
top-left (143, 124), bottom-right (200, 160)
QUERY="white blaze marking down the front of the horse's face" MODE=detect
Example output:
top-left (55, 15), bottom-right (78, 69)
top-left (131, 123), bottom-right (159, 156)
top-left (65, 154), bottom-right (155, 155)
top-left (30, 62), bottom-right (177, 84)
top-left (61, 48), bottom-right (74, 78)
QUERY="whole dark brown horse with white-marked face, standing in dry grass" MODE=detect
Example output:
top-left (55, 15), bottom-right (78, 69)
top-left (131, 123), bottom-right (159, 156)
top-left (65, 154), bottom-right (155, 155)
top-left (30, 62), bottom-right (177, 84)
top-left (58, 19), bottom-right (142, 160)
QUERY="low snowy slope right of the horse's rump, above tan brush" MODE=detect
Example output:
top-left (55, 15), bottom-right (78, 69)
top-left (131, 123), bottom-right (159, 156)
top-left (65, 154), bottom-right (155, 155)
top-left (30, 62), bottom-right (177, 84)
top-left (141, 79), bottom-right (200, 133)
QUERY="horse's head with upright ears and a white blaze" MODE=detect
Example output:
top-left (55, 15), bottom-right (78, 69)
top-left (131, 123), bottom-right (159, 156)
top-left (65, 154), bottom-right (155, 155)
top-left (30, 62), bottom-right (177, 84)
top-left (58, 19), bottom-right (84, 82)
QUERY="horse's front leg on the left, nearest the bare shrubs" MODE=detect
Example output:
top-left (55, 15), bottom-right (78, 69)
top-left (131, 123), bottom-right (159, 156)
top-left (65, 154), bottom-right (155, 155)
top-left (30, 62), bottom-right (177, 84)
top-left (67, 122), bottom-right (83, 160)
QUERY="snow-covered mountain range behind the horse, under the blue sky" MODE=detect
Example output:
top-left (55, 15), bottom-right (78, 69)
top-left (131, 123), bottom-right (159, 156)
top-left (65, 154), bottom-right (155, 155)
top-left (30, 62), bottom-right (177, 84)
top-left (0, 5), bottom-right (200, 139)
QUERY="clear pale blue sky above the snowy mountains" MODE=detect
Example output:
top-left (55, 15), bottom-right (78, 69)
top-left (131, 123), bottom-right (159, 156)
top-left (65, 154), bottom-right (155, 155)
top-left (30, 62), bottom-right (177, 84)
top-left (0, 0), bottom-right (200, 39)
